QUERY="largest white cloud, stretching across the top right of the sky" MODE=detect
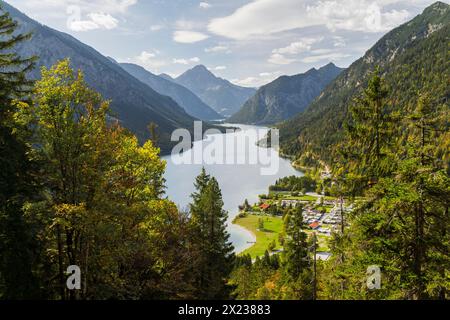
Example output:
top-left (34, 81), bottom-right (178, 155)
top-left (208, 0), bottom-right (409, 40)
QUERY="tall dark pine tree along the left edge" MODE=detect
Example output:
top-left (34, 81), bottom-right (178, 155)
top-left (0, 4), bottom-right (39, 299)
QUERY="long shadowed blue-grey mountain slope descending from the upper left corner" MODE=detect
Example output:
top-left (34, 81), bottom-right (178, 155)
top-left (0, 1), bottom-right (206, 153)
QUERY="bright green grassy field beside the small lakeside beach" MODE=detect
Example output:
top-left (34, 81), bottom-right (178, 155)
top-left (234, 215), bottom-right (283, 259)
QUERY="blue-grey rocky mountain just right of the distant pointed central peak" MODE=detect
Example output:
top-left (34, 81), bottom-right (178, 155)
top-left (228, 63), bottom-right (343, 125)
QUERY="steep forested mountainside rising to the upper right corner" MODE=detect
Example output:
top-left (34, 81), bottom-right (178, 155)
top-left (279, 2), bottom-right (450, 162)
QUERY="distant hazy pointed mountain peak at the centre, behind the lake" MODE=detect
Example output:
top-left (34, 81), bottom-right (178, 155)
top-left (173, 65), bottom-right (256, 117)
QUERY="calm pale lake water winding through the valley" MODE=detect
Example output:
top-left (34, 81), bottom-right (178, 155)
top-left (164, 124), bottom-right (303, 252)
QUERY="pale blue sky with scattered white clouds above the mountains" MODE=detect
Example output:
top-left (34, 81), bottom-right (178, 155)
top-left (7, 0), bottom-right (448, 87)
